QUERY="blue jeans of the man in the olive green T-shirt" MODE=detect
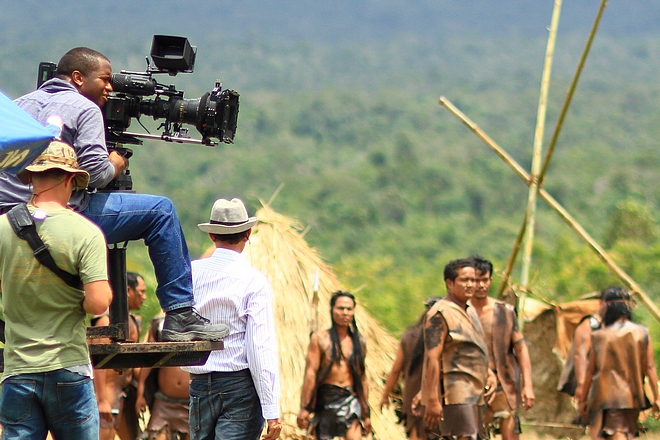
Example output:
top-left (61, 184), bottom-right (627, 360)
top-left (0, 370), bottom-right (99, 440)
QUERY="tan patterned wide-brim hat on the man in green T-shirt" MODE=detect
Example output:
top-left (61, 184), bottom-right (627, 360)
top-left (16, 140), bottom-right (89, 189)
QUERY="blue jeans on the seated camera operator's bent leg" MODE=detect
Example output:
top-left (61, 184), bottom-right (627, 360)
top-left (81, 192), bottom-right (193, 311)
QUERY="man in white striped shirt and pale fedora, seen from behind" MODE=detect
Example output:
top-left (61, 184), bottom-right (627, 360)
top-left (184, 199), bottom-right (282, 440)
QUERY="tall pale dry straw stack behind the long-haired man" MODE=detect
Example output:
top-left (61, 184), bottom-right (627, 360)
top-left (245, 204), bottom-right (405, 440)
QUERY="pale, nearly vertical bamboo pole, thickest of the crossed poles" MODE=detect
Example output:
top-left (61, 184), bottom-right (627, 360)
top-left (512, 0), bottom-right (562, 330)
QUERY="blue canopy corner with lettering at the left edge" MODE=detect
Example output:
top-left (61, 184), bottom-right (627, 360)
top-left (0, 92), bottom-right (55, 173)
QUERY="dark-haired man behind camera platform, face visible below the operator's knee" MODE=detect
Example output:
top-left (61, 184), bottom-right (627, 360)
top-left (93, 272), bottom-right (147, 440)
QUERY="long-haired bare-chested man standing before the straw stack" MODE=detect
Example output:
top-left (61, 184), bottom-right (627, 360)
top-left (298, 290), bottom-right (371, 440)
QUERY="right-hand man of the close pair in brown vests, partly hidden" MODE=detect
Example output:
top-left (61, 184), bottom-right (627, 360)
top-left (470, 256), bottom-right (534, 440)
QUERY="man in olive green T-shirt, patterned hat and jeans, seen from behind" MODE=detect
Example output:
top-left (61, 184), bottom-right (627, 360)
top-left (0, 141), bottom-right (112, 439)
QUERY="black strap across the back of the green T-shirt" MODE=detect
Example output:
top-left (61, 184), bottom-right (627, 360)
top-left (7, 203), bottom-right (83, 290)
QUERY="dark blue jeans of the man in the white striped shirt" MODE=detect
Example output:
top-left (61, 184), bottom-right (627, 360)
top-left (189, 370), bottom-right (264, 440)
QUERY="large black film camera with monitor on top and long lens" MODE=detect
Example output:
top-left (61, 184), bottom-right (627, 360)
top-left (37, 35), bottom-right (239, 191)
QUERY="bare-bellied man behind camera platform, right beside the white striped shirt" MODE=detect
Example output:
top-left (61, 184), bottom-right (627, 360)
top-left (135, 315), bottom-right (190, 440)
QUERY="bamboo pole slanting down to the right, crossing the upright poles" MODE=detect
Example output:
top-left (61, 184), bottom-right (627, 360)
top-left (438, 96), bottom-right (660, 321)
